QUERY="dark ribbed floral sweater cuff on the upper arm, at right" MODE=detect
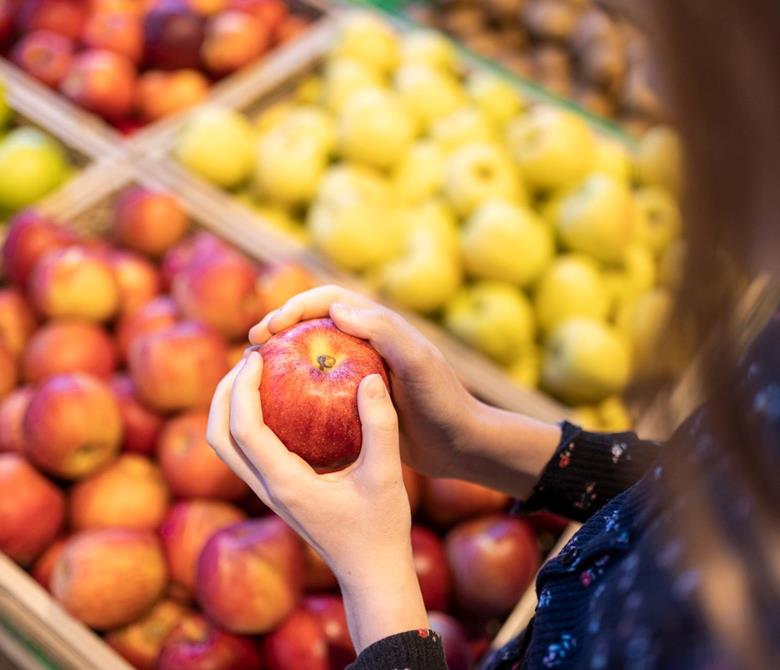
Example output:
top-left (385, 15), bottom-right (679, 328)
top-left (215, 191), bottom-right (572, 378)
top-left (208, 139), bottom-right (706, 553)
top-left (513, 422), bottom-right (660, 522)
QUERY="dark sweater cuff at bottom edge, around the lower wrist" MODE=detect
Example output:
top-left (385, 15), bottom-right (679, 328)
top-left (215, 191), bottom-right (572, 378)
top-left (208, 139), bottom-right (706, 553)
top-left (347, 628), bottom-right (447, 670)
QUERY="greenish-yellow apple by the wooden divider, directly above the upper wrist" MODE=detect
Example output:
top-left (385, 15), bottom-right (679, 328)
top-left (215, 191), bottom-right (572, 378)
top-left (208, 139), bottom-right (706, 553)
top-left (444, 281), bottom-right (534, 365)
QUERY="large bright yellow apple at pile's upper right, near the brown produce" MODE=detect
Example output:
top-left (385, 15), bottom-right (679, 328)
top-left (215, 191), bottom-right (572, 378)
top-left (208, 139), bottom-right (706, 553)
top-left (507, 106), bottom-right (596, 191)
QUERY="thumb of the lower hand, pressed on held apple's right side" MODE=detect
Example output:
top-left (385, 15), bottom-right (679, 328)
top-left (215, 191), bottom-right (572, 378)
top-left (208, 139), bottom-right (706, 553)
top-left (358, 374), bottom-right (401, 477)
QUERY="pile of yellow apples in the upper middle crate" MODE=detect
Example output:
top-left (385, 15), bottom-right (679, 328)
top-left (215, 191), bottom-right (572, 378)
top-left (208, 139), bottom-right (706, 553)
top-left (176, 13), bottom-right (681, 425)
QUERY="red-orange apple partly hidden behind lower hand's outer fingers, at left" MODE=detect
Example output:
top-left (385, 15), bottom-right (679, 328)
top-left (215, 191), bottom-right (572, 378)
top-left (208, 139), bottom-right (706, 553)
top-left (157, 410), bottom-right (249, 500)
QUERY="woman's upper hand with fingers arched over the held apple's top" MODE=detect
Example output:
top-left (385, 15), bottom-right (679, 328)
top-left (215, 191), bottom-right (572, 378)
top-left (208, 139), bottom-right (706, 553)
top-left (249, 286), bottom-right (481, 477)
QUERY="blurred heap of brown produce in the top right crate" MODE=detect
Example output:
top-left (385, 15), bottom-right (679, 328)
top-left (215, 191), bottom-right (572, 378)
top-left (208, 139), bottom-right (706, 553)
top-left (409, 0), bottom-right (663, 134)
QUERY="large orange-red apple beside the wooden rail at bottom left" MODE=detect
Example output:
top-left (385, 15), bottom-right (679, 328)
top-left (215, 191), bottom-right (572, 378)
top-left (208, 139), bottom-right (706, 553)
top-left (51, 528), bottom-right (167, 630)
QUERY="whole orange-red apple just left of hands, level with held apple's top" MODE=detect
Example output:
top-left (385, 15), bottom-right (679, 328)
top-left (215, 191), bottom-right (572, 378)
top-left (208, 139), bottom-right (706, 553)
top-left (128, 321), bottom-right (228, 412)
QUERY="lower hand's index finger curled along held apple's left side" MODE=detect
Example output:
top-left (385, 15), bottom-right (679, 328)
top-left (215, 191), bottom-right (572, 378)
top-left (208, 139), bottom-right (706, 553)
top-left (230, 351), bottom-right (315, 484)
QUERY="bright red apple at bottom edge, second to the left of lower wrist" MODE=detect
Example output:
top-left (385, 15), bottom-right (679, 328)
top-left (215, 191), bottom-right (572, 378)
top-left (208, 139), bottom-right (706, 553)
top-left (263, 608), bottom-right (330, 670)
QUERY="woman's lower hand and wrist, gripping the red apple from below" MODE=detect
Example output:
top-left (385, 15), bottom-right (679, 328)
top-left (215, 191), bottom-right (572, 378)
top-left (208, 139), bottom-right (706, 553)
top-left (207, 351), bottom-right (428, 653)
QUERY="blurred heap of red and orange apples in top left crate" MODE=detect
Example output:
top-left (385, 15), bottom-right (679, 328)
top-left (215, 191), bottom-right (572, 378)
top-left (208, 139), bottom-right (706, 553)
top-left (0, 0), bottom-right (314, 132)
